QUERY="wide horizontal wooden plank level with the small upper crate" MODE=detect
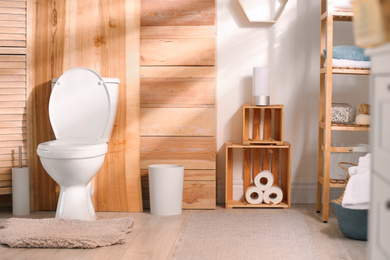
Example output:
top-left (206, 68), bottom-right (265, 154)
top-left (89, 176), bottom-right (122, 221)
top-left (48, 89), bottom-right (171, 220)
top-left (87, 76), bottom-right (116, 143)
top-left (140, 108), bottom-right (215, 136)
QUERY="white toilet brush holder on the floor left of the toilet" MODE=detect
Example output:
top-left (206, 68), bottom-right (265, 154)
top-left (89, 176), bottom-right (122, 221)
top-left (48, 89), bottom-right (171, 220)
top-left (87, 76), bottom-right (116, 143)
top-left (12, 167), bottom-right (30, 216)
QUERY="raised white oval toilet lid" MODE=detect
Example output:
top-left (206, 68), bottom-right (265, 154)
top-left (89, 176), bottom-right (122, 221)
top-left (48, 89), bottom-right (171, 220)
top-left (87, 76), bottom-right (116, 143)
top-left (49, 68), bottom-right (110, 139)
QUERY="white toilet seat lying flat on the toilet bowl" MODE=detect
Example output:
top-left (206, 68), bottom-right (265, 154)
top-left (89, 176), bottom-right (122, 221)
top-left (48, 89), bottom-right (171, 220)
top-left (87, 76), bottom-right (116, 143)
top-left (37, 140), bottom-right (107, 159)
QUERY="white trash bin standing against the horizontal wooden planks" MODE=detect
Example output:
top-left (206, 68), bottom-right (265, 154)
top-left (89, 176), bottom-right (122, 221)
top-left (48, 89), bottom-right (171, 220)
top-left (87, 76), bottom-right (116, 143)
top-left (149, 164), bottom-right (184, 216)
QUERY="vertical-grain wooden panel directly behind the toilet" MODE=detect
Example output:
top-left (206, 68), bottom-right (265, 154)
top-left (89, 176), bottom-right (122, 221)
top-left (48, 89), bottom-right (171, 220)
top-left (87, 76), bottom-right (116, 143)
top-left (29, 0), bottom-right (142, 211)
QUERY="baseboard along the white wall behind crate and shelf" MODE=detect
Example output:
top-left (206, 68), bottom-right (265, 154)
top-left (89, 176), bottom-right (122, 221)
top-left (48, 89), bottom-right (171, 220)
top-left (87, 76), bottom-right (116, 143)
top-left (217, 180), bottom-right (343, 204)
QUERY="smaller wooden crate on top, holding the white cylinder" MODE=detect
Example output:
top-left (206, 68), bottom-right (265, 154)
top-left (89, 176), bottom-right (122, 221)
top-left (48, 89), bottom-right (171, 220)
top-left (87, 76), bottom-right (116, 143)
top-left (242, 105), bottom-right (283, 145)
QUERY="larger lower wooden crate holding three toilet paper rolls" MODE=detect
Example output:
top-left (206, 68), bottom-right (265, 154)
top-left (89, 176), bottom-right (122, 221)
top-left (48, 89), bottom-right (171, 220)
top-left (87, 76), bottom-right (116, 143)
top-left (225, 142), bottom-right (291, 208)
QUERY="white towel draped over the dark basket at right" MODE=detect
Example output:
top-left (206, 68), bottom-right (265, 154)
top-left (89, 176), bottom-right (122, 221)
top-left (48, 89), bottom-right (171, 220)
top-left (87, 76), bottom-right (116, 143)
top-left (341, 153), bottom-right (371, 209)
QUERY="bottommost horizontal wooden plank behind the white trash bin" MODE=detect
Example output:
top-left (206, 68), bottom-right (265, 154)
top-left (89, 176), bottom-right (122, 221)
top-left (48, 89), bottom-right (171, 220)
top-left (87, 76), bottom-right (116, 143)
top-left (142, 180), bottom-right (216, 209)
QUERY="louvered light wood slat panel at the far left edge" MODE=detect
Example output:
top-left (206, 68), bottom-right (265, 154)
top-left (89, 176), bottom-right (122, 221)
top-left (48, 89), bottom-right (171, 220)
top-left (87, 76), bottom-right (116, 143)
top-left (0, 0), bottom-right (27, 207)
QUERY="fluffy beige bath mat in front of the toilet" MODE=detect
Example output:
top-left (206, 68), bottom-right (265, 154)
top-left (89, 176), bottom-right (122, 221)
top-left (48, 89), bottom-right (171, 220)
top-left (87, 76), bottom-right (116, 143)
top-left (0, 217), bottom-right (134, 248)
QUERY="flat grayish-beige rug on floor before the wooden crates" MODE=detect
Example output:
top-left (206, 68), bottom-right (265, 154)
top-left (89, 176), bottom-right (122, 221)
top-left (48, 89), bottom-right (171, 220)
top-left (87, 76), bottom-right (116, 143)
top-left (173, 213), bottom-right (319, 260)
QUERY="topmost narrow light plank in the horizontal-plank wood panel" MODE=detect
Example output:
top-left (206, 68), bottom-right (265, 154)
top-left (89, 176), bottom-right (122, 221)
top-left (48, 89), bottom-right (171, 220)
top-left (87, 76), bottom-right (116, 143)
top-left (141, 26), bottom-right (215, 39)
